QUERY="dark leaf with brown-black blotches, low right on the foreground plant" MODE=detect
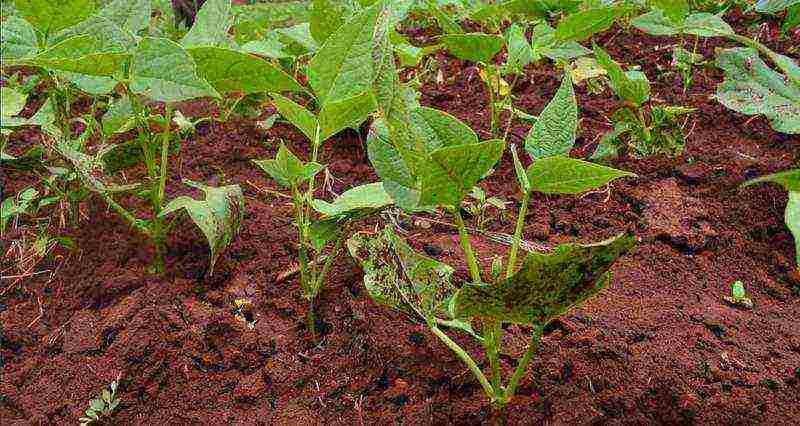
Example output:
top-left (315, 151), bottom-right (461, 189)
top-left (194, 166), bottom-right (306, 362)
top-left (454, 235), bottom-right (637, 326)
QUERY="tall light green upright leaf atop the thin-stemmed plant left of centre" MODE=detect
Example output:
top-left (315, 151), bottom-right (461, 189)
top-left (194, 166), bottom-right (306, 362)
top-left (308, 6), bottom-right (380, 106)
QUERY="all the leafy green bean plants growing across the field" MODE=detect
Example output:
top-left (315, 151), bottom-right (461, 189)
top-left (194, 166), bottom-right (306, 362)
top-left (0, 0), bottom-right (800, 414)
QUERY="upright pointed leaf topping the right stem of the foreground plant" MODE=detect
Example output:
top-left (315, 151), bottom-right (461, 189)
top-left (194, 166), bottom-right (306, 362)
top-left (525, 73), bottom-right (578, 159)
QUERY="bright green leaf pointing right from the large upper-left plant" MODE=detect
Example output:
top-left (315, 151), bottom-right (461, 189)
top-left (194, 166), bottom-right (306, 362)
top-left (187, 47), bottom-right (303, 94)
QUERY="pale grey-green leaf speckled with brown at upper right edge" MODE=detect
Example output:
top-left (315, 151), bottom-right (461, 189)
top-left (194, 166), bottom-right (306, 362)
top-left (716, 48), bottom-right (800, 134)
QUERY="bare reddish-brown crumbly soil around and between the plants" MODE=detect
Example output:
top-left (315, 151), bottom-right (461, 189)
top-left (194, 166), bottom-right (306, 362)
top-left (0, 19), bottom-right (800, 425)
